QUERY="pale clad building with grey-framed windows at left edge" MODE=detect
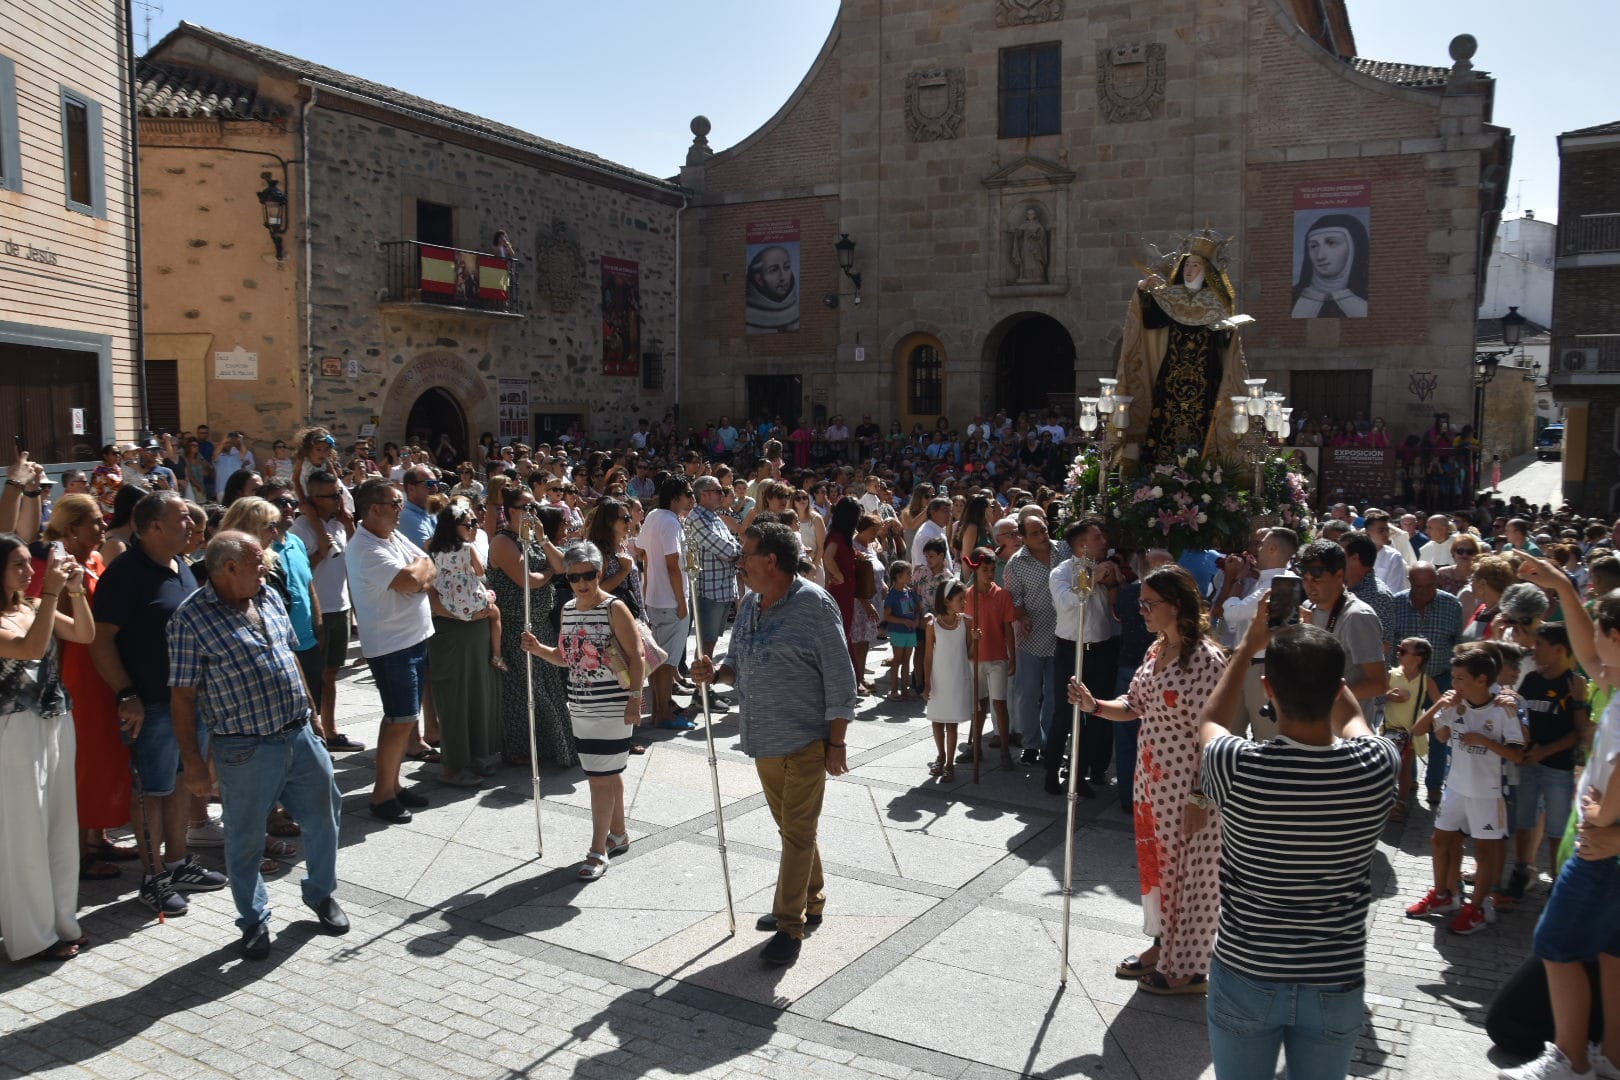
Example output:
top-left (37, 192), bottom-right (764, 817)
top-left (0, 0), bottom-right (144, 465)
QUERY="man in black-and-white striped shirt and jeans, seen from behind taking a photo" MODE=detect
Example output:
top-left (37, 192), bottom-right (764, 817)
top-left (1192, 599), bottom-right (1400, 1080)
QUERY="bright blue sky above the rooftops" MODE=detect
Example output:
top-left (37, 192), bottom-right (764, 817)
top-left (149, 0), bottom-right (1620, 220)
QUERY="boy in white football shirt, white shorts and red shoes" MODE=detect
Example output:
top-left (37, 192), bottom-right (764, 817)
top-left (1406, 644), bottom-right (1524, 934)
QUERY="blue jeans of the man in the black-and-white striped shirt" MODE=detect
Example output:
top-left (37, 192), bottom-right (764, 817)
top-left (1209, 957), bottom-right (1367, 1080)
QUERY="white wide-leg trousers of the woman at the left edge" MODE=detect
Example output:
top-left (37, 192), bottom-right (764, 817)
top-left (0, 709), bottom-right (79, 960)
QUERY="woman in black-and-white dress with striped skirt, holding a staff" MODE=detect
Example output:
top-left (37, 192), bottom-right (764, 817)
top-left (523, 542), bottom-right (646, 881)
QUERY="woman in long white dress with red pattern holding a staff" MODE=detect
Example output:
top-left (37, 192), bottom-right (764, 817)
top-left (1069, 567), bottom-right (1226, 994)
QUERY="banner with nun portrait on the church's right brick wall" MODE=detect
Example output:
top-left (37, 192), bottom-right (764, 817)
top-left (1293, 180), bottom-right (1372, 319)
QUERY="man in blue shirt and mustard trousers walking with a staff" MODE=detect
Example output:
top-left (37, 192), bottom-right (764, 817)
top-left (692, 521), bottom-right (855, 967)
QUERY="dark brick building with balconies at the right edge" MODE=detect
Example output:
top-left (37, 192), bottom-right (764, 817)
top-left (1550, 121), bottom-right (1620, 518)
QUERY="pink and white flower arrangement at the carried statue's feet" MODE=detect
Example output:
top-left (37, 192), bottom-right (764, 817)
top-left (1064, 449), bottom-right (1314, 557)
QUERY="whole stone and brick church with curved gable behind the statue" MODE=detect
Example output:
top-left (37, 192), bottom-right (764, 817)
top-left (680, 0), bottom-right (1511, 450)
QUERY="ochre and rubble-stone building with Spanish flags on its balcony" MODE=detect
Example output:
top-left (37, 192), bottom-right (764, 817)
top-left (131, 23), bottom-right (682, 455)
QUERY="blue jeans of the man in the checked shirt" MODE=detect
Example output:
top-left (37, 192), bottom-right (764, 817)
top-left (212, 722), bottom-right (343, 934)
